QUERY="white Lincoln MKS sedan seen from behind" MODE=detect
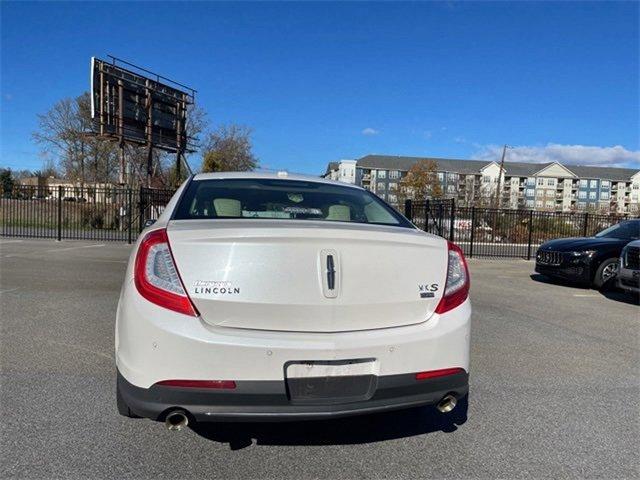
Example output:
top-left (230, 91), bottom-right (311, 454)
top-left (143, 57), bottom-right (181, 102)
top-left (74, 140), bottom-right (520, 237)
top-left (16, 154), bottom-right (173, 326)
top-left (115, 173), bottom-right (471, 429)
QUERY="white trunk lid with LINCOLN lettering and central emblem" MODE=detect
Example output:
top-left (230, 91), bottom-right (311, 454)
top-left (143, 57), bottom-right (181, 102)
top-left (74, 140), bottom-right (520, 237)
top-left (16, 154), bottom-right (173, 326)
top-left (167, 220), bottom-right (447, 332)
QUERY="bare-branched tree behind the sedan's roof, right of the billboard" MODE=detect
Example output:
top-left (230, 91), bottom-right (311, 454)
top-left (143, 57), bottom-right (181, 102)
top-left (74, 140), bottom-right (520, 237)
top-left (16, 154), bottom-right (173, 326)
top-left (202, 125), bottom-right (258, 172)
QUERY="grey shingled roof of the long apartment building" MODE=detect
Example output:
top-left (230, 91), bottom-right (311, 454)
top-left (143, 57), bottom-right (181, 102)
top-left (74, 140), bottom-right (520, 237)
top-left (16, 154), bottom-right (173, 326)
top-left (352, 155), bottom-right (640, 181)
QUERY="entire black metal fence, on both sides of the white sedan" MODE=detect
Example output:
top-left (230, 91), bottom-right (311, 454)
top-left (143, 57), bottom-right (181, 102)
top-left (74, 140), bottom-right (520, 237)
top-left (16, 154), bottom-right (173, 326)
top-left (0, 185), bottom-right (626, 255)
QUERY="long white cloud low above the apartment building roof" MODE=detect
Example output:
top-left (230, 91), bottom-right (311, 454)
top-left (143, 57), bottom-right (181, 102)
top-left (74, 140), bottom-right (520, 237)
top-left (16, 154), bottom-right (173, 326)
top-left (474, 143), bottom-right (640, 168)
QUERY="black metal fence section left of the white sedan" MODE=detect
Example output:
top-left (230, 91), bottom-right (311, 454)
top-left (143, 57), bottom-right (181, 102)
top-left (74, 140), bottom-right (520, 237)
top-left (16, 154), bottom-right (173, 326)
top-left (0, 185), bottom-right (174, 243)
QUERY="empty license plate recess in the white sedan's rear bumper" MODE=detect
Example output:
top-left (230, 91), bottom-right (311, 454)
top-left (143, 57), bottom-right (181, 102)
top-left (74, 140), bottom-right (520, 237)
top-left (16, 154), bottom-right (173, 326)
top-left (285, 358), bottom-right (378, 405)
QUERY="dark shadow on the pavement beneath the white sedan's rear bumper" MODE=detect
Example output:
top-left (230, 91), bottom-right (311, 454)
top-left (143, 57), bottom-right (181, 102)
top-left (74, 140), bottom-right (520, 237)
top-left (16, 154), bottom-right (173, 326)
top-left (192, 401), bottom-right (468, 450)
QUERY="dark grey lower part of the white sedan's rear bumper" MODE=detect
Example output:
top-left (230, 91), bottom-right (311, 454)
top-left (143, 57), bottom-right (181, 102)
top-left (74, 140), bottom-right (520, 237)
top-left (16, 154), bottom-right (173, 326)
top-left (117, 371), bottom-right (469, 422)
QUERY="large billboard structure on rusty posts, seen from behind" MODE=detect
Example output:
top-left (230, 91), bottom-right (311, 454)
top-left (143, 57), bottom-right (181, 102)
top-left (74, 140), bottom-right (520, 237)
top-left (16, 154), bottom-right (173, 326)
top-left (91, 55), bottom-right (196, 184)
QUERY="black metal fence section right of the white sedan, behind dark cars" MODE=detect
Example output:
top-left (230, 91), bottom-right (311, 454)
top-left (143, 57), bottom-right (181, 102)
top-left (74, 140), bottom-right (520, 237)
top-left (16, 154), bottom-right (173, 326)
top-left (405, 200), bottom-right (629, 259)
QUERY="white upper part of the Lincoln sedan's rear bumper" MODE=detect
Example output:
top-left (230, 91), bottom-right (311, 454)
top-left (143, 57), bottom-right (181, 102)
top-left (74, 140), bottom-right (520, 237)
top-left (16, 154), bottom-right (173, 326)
top-left (116, 280), bottom-right (471, 389)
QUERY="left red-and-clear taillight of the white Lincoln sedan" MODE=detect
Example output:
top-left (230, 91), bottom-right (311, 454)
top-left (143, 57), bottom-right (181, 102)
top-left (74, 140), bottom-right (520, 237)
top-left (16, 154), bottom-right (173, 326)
top-left (134, 228), bottom-right (198, 317)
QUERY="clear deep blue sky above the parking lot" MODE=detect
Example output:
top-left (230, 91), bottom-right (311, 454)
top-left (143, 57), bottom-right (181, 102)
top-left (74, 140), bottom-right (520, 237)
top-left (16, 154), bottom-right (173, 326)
top-left (0, 2), bottom-right (640, 173)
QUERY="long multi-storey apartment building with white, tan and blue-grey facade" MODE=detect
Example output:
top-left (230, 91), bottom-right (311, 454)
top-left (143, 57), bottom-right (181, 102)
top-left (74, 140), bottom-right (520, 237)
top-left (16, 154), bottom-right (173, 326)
top-left (323, 155), bottom-right (640, 214)
